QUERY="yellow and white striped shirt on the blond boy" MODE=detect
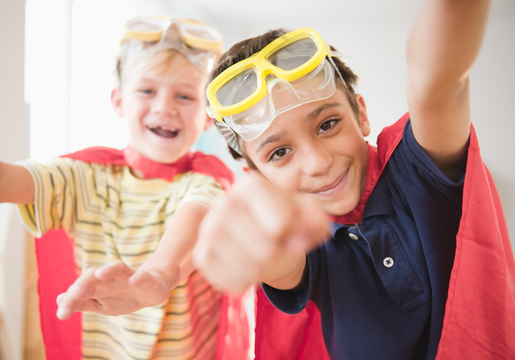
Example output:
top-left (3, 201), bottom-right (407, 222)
top-left (18, 158), bottom-right (223, 360)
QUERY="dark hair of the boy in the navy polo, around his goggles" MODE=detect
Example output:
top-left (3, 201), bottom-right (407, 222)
top-left (209, 29), bottom-right (359, 165)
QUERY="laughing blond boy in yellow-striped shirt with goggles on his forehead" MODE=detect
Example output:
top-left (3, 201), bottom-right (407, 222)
top-left (0, 17), bottom-right (248, 359)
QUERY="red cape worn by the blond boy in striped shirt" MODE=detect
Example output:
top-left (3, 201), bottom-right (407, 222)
top-left (36, 147), bottom-right (249, 360)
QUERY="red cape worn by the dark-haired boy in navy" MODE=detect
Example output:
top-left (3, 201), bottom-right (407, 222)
top-left (256, 114), bottom-right (515, 360)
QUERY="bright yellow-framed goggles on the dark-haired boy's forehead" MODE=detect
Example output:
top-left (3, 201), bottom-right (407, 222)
top-left (206, 28), bottom-right (345, 154)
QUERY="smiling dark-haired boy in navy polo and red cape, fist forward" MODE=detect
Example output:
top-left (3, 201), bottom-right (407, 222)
top-left (197, 0), bottom-right (515, 360)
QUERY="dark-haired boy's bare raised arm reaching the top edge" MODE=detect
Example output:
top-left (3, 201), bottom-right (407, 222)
top-left (407, 0), bottom-right (490, 178)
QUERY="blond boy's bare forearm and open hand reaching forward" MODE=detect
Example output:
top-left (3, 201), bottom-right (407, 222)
top-left (57, 203), bottom-right (209, 320)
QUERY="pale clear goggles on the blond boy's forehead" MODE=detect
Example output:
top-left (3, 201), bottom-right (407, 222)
top-left (121, 16), bottom-right (222, 73)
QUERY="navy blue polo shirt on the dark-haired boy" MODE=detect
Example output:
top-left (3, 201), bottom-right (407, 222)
top-left (262, 121), bottom-right (463, 360)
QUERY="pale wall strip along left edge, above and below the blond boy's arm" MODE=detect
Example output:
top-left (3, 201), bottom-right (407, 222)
top-left (0, 1), bottom-right (29, 360)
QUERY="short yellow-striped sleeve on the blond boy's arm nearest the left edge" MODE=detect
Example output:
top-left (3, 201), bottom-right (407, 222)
top-left (17, 158), bottom-right (80, 237)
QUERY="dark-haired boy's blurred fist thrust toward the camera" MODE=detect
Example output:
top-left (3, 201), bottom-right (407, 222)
top-left (193, 176), bottom-right (328, 293)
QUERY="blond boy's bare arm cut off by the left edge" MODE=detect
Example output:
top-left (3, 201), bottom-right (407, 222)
top-left (0, 162), bottom-right (34, 204)
